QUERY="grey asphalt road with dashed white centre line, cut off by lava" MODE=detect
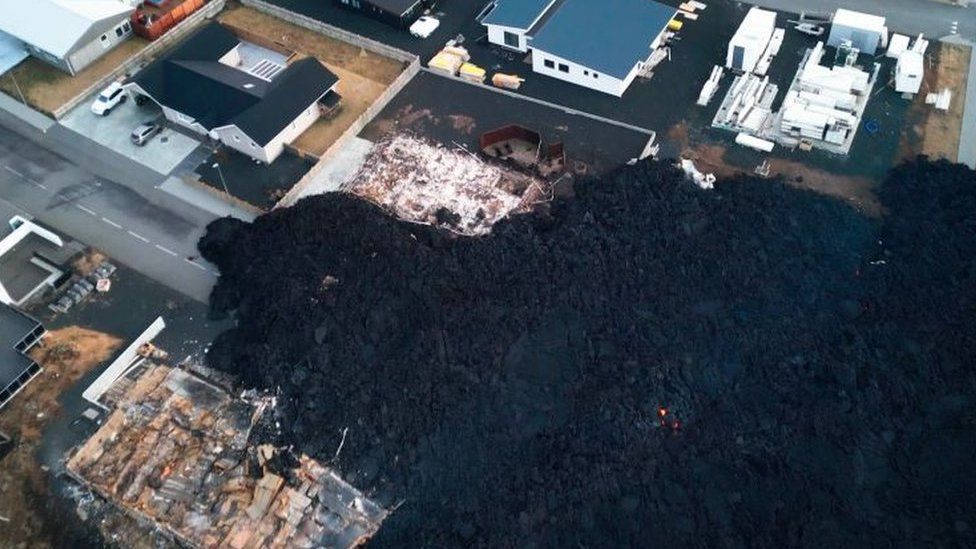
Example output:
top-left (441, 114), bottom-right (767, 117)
top-left (0, 126), bottom-right (217, 302)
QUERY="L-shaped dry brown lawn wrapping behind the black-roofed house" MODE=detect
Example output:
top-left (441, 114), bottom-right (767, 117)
top-left (220, 3), bottom-right (403, 155)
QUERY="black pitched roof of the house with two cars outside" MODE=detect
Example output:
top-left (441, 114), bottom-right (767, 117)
top-left (130, 23), bottom-right (339, 146)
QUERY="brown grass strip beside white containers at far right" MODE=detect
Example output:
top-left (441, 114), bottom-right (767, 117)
top-left (899, 43), bottom-right (972, 162)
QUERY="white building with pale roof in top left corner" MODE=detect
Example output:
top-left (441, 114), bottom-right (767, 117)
top-left (0, 0), bottom-right (135, 74)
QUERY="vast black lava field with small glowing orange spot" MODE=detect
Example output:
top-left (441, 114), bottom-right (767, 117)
top-left (201, 159), bottom-right (976, 548)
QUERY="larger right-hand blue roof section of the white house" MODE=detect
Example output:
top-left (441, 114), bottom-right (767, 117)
top-left (529, 0), bottom-right (677, 79)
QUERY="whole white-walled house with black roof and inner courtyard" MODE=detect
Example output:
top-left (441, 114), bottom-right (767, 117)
top-left (125, 23), bottom-right (339, 164)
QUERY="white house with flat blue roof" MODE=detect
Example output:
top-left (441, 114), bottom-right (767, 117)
top-left (481, 0), bottom-right (677, 97)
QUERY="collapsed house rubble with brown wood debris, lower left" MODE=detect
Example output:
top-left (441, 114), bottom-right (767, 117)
top-left (68, 365), bottom-right (387, 549)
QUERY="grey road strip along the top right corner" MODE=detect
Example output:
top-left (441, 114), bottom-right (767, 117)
top-left (748, 0), bottom-right (976, 40)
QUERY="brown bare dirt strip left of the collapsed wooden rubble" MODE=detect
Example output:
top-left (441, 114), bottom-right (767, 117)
top-left (0, 327), bottom-right (121, 547)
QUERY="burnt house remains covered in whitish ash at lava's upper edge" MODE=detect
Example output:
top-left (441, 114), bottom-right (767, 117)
top-left (343, 133), bottom-right (548, 235)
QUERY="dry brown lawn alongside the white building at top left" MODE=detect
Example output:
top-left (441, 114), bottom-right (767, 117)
top-left (0, 36), bottom-right (149, 115)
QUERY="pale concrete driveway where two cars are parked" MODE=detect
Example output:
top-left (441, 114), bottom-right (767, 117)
top-left (60, 90), bottom-right (200, 175)
